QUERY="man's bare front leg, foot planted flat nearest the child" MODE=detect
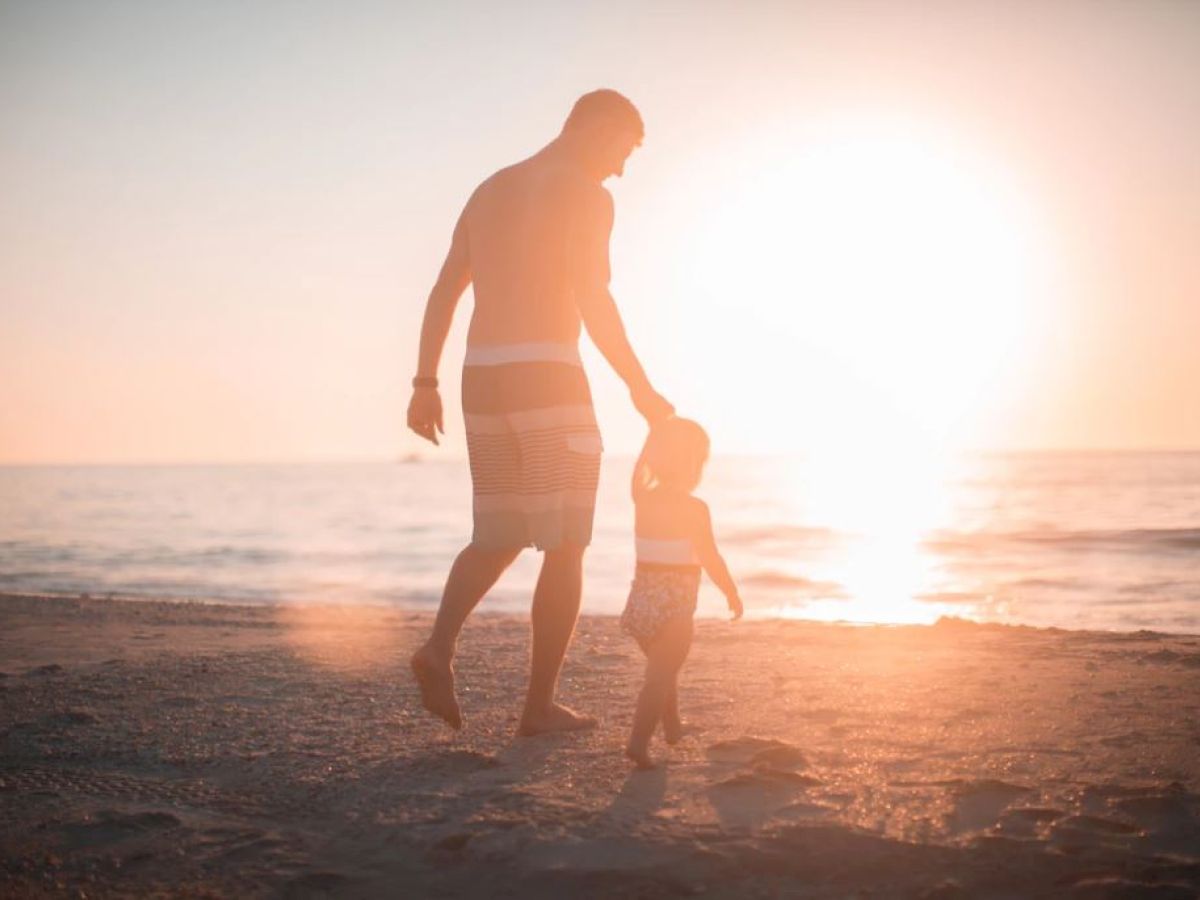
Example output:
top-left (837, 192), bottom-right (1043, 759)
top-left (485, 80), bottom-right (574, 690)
top-left (517, 544), bottom-right (595, 734)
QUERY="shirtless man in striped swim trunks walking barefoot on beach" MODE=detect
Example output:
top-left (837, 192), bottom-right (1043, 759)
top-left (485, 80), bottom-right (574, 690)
top-left (408, 90), bottom-right (672, 734)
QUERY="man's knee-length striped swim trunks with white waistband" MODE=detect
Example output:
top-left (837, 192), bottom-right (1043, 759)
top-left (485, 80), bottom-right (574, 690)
top-left (462, 343), bottom-right (602, 550)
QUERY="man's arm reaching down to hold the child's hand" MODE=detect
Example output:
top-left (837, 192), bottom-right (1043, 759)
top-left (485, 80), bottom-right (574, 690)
top-left (571, 190), bottom-right (674, 424)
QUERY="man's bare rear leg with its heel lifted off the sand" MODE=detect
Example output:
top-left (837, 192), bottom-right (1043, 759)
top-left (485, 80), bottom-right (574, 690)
top-left (410, 544), bottom-right (521, 730)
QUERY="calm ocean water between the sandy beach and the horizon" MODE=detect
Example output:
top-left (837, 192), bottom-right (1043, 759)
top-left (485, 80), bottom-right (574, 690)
top-left (0, 450), bottom-right (1200, 634)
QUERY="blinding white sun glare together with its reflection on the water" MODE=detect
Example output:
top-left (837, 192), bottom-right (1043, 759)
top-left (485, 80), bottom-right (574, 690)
top-left (683, 118), bottom-right (1048, 623)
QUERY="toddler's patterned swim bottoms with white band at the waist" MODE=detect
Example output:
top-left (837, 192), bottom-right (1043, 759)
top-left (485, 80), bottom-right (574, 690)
top-left (620, 538), bottom-right (700, 644)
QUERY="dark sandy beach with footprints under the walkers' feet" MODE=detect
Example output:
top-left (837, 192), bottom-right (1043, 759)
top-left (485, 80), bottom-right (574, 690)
top-left (0, 595), bottom-right (1200, 898)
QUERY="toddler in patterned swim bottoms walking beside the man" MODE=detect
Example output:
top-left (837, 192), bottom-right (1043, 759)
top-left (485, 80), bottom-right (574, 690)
top-left (620, 416), bottom-right (742, 769)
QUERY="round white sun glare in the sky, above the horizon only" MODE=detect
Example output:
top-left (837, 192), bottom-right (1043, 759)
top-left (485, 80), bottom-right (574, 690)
top-left (680, 112), bottom-right (1045, 448)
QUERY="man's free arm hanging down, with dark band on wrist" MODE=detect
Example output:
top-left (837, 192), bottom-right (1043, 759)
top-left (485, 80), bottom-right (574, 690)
top-left (408, 211), bottom-right (470, 444)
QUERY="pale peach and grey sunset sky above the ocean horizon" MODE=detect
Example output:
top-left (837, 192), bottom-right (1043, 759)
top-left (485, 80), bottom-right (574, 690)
top-left (0, 0), bottom-right (1200, 463)
